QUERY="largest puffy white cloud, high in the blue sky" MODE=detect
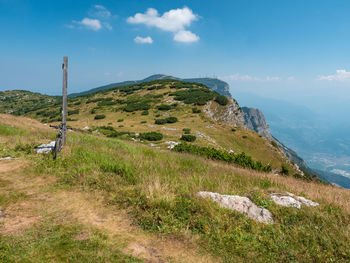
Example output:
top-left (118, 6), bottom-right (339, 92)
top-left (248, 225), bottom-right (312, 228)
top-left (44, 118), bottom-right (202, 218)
top-left (126, 7), bottom-right (199, 43)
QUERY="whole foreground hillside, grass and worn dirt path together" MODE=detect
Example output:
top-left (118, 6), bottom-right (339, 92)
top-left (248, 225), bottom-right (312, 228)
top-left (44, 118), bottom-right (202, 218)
top-left (0, 115), bottom-right (350, 262)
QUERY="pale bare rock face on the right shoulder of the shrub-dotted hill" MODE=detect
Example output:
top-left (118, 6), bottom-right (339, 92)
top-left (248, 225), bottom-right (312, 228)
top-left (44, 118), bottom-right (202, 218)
top-left (203, 98), bottom-right (245, 127)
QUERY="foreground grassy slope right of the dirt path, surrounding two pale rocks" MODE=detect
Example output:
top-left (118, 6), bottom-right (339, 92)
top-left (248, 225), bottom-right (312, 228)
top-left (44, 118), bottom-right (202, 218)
top-left (0, 115), bottom-right (350, 262)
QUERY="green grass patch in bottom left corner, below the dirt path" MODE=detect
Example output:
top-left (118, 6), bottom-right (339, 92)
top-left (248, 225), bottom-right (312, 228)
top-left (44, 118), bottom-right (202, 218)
top-left (0, 221), bottom-right (143, 263)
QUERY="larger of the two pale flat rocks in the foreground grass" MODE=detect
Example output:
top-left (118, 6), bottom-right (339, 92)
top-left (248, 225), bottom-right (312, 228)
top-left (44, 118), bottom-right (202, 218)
top-left (197, 192), bottom-right (273, 224)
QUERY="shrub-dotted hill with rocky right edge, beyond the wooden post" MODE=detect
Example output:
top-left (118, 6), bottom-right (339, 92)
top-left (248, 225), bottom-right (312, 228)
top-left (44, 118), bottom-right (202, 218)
top-left (0, 79), bottom-right (310, 178)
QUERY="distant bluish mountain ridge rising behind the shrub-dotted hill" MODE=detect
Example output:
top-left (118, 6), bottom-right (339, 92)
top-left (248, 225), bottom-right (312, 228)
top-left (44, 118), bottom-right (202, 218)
top-left (69, 74), bottom-right (231, 97)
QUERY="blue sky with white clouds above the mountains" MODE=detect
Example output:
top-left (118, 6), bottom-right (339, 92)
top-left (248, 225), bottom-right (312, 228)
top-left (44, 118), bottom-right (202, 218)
top-left (0, 0), bottom-right (350, 116)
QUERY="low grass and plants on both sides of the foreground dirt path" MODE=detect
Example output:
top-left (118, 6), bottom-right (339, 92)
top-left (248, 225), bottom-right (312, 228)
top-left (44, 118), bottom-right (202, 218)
top-left (0, 116), bottom-right (350, 263)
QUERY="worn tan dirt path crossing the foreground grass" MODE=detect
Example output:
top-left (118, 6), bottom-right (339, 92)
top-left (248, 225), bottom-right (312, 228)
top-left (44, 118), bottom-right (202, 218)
top-left (0, 160), bottom-right (218, 263)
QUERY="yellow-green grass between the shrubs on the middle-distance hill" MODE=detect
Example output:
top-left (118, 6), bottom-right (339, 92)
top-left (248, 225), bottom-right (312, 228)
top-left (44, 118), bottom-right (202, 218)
top-left (0, 82), bottom-right (296, 174)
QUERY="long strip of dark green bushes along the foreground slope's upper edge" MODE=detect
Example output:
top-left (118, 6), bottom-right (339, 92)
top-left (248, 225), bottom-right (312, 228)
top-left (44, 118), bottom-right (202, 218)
top-left (173, 143), bottom-right (272, 172)
